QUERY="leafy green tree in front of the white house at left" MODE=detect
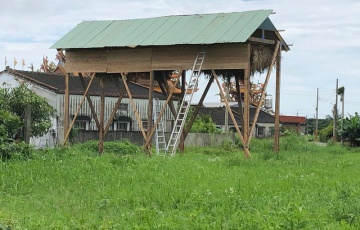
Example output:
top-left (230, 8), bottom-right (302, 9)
top-left (0, 83), bottom-right (55, 137)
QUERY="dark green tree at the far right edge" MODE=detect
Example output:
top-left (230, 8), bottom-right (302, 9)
top-left (338, 113), bottom-right (360, 147)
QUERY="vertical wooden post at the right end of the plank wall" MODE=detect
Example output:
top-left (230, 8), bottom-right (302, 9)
top-left (243, 44), bottom-right (250, 145)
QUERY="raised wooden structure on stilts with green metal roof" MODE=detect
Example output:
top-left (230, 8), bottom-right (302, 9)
top-left (52, 10), bottom-right (289, 157)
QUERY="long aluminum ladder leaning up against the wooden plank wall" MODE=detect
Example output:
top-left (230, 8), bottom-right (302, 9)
top-left (166, 46), bottom-right (206, 157)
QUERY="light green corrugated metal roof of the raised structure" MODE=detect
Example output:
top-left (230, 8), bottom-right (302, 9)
top-left (50, 10), bottom-right (276, 49)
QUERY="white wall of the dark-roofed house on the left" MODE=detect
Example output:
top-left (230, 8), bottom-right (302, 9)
top-left (0, 73), bottom-right (177, 148)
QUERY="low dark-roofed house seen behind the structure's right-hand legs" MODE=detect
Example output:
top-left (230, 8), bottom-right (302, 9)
top-left (194, 106), bottom-right (275, 138)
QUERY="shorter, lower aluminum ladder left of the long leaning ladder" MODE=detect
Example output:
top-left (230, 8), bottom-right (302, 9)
top-left (153, 98), bottom-right (166, 156)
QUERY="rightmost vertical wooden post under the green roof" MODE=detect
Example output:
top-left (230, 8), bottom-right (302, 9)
top-left (274, 43), bottom-right (281, 153)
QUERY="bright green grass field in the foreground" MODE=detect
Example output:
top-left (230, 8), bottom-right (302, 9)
top-left (0, 137), bottom-right (360, 229)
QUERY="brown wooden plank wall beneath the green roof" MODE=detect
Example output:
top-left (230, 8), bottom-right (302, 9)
top-left (66, 43), bottom-right (249, 73)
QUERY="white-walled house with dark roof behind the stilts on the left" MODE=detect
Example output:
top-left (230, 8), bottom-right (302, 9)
top-left (0, 67), bottom-right (176, 147)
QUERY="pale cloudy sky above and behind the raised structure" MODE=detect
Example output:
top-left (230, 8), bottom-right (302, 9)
top-left (0, 0), bottom-right (360, 118)
